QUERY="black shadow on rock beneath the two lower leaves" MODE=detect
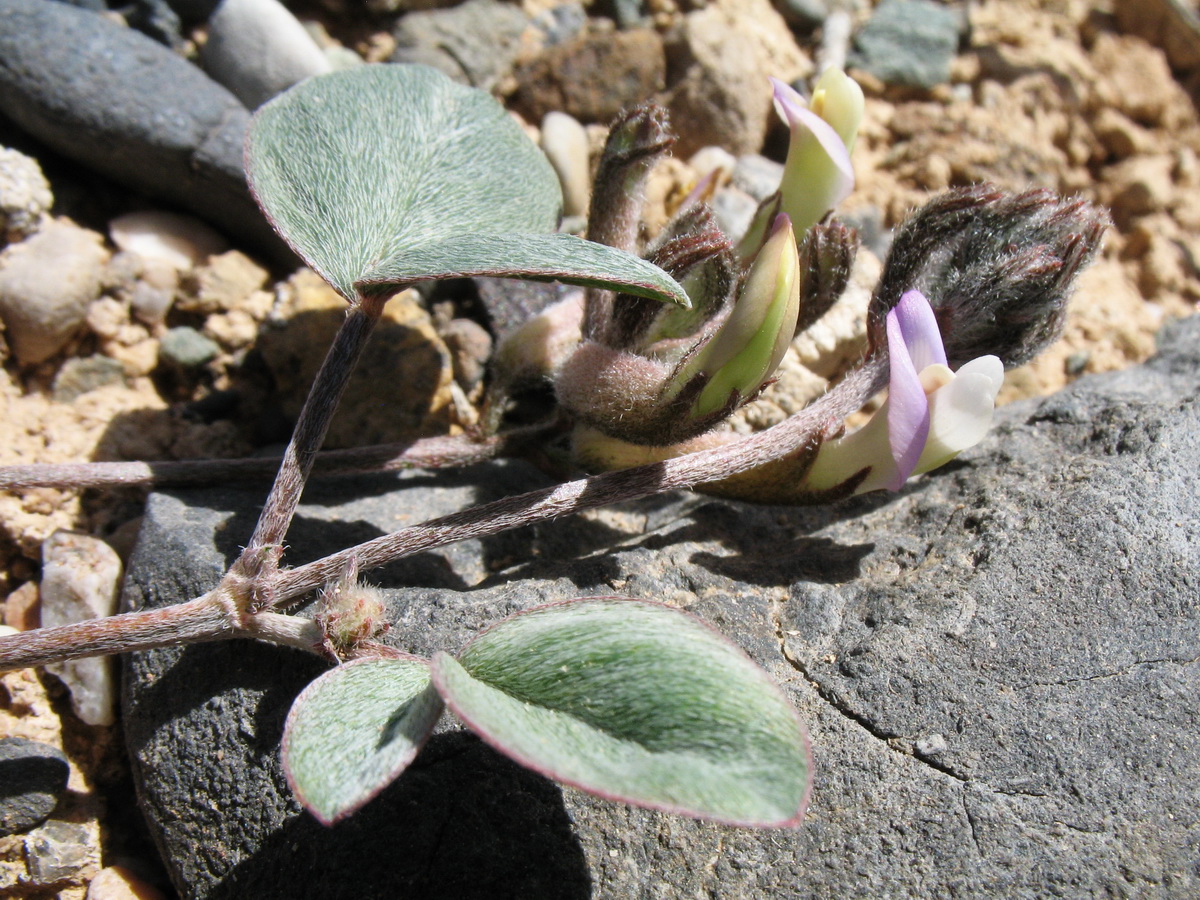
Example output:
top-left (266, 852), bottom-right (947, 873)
top-left (208, 733), bottom-right (592, 900)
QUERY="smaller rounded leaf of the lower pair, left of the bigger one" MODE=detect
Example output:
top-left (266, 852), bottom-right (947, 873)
top-left (282, 659), bottom-right (443, 824)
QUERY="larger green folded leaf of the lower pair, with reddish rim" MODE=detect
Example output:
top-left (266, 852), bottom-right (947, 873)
top-left (432, 598), bottom-right (810, 827)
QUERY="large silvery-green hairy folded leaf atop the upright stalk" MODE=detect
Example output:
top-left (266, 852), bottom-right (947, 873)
top-left (246, 65), bottom-right (688, 306)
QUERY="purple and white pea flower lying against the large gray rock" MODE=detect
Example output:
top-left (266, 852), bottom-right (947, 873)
top-left (806, 290), bottom-right (1004, 493)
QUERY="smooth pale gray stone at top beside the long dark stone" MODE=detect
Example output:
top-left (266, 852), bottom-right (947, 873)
top-left (200, 0), bottom-right (332, 109)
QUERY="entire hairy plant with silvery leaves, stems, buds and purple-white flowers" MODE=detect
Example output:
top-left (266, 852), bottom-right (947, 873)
top-left (0, 66), bottom-right (1104, 827)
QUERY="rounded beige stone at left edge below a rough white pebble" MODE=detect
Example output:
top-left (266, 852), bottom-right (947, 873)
top-left (0, 220), bottom-right (108, 365)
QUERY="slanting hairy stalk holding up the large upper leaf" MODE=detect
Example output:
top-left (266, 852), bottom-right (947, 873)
top-left (233, 295), bottom-right (388, 585)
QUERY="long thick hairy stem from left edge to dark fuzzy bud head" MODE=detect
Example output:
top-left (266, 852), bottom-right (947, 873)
top-left (0, 355), bottom-right (888, 672)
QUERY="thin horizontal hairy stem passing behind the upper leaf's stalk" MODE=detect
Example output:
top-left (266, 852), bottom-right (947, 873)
top-left (0, 425), bottom-right (551, 491)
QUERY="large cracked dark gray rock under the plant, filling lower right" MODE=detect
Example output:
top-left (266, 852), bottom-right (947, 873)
top-left (126, 317), bottom-right (1200, 900)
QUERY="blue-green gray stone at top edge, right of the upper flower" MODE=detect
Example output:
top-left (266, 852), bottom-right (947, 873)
top-left (850, 0), bottom-right (964, 89)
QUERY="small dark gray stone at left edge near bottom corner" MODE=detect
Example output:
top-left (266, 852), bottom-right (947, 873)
top-left (0, 738), bottom-right (71, 838)
